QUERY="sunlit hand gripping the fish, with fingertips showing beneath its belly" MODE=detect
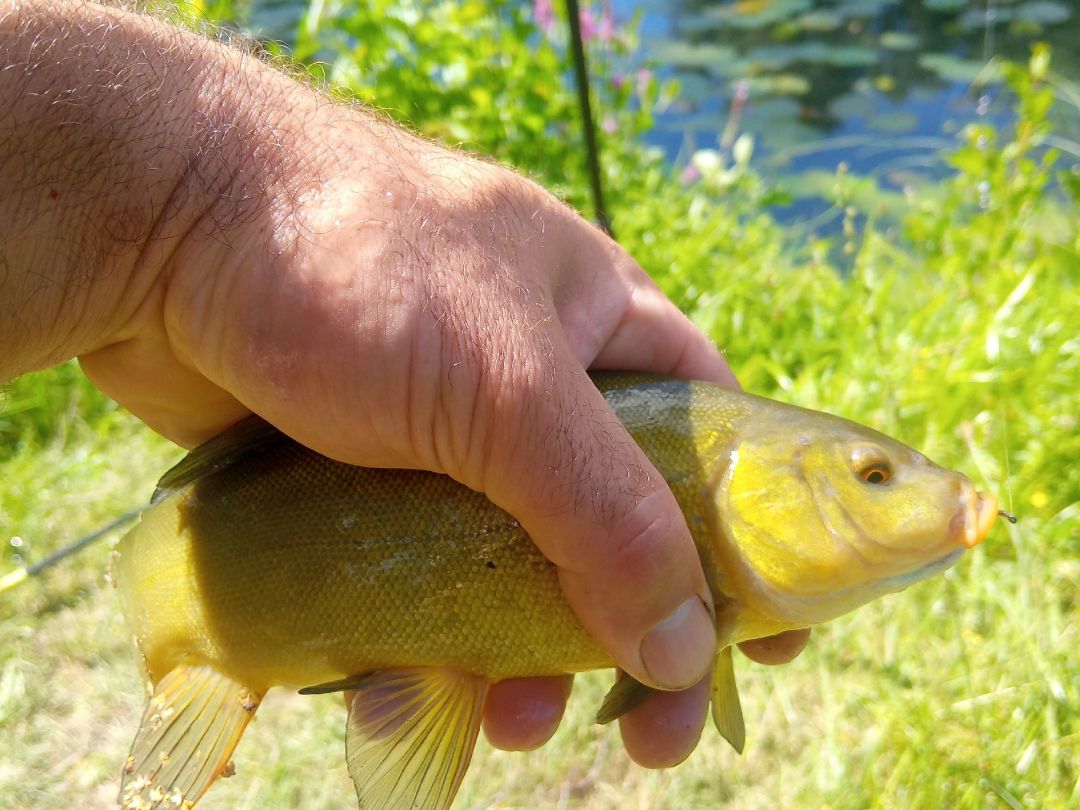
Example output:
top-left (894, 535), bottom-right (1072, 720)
top-left (82, 135), bottom-right (812, 765)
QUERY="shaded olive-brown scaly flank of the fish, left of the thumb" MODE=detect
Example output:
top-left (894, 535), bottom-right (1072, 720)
top-left (119, 443), bottom-right (610, 689)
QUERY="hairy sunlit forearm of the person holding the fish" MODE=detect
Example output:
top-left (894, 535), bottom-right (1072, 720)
top-left (0, 0), bottom-right (321, 382)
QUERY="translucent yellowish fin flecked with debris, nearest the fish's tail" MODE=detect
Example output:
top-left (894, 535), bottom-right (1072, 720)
top-left (119, 665), bottom-right (262, 810)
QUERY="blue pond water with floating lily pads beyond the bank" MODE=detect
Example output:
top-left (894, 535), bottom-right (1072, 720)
top-left (612, 0), bottom-right (1080, 227)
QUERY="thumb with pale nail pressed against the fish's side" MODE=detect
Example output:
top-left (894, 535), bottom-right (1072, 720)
top-left (484, 357), bottom-right (716, 689)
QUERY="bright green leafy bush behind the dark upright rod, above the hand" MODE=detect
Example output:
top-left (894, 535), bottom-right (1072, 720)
top-left (282, 0), bottom-right (658, 212)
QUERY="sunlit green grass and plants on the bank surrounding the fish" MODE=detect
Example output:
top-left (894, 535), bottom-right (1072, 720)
top-left (0, 3), bottom-right (1080, 810)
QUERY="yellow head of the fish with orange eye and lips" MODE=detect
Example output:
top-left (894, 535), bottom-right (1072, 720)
top-left (713, 406), bottom-right (998, 626)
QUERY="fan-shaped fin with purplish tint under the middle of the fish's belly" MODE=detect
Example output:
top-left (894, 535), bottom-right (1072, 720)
top-left (346, 667), bottom-right (488, 810)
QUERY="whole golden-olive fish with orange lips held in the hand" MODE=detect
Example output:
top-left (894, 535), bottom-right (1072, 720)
top-left (112, 373), bottom-right (998, 810)
